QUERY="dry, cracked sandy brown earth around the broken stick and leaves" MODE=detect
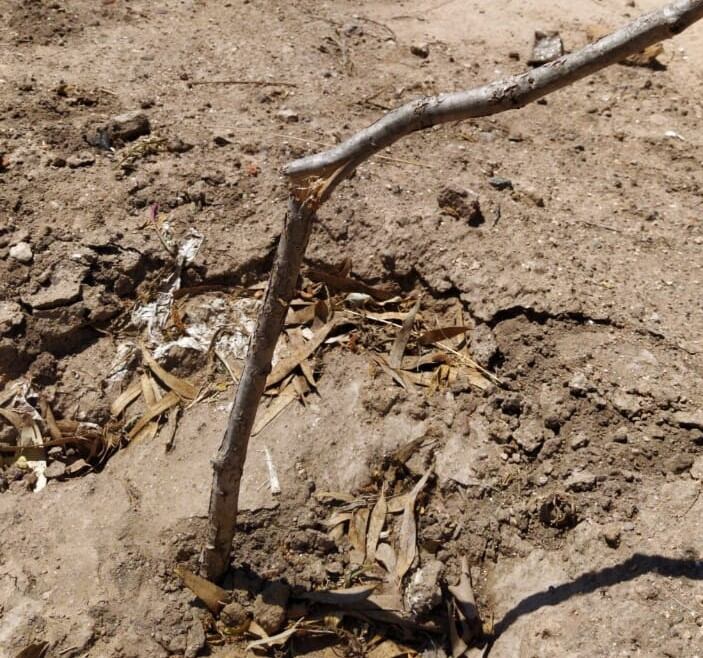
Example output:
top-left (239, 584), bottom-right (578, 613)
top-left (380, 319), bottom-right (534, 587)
top-left (0, 0), bottom-right (703, 658)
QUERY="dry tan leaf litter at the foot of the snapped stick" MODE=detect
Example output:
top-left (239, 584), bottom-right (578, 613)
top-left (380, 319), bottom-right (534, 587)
top-left (175, 462), bottom-right (490, 658)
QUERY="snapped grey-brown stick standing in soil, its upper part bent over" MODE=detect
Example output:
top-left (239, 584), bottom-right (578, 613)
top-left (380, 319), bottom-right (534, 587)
top-left (202, 0), bottom-right (703, 581)
